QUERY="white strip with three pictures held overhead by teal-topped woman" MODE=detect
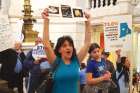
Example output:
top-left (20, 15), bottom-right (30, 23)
top-left (44, 5), bottom-right (86, 21)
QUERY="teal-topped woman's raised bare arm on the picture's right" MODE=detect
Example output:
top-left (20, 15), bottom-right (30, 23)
top-left (78, 13), bottom-right (92, 62)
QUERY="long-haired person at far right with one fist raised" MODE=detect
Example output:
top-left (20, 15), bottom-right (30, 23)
top-left (115, 49), bottom-right (130, 93)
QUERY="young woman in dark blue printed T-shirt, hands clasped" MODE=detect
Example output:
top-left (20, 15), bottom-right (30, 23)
top-left (86, 43), bottom-right (111, 93)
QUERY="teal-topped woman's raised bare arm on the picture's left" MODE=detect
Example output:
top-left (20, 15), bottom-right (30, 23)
top-left (42, 9), bottom-right (56, 63)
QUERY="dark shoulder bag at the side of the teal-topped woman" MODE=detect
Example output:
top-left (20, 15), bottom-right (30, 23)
top-left (36, 63), bottom-right (59, 93)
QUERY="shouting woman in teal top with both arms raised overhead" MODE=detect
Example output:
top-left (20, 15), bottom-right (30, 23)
top-left (42, 9), bottom-right (91, 93)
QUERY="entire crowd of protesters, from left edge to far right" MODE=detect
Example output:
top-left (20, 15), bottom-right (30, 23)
top-left (0, 9), bottom-right (137, 93)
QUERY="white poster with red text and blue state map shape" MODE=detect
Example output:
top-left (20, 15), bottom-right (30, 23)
top-left (104, 15), bottom-right (132, 51)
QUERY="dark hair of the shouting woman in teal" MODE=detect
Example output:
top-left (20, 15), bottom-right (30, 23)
top-left (54, 36), bottom-right (76, 58)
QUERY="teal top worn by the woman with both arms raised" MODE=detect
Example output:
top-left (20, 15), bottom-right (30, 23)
top-left (53, 57), bottom-right (79, 93)
